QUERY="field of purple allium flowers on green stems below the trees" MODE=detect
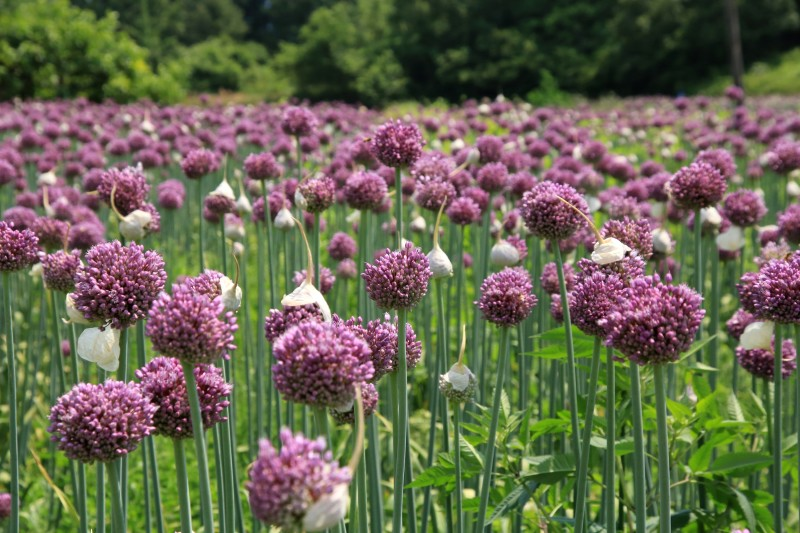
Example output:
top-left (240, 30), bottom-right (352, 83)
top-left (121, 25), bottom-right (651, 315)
top-left (0, 93), bottom-right (800, 533)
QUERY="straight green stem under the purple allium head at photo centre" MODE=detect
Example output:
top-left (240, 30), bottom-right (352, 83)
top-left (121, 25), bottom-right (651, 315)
top-left (392, 308), bottom-right (414, 531)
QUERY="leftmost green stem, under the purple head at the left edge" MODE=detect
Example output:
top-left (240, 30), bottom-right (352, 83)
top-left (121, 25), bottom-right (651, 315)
top-left (3, 272), bottom-right (19, 533)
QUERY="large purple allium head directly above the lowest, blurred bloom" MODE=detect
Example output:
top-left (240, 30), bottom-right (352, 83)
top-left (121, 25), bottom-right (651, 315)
top-left (272, 320), bottom-right (374, 408)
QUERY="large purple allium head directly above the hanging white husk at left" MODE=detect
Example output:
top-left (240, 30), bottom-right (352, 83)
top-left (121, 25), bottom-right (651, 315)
top-left (74, 241), bottom-right (167, 329)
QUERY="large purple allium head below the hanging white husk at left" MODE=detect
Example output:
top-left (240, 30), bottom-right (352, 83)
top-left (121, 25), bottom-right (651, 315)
top-left (47, 380), bottom-right (158, 463)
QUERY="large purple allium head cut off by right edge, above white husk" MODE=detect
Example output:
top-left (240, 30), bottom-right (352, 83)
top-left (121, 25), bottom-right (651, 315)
top-left (742, 252), bottom-right (800, 324)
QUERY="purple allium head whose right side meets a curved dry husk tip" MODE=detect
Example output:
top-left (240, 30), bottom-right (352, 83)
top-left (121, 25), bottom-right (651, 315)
top-left (520, 181), bottom-right (589, 241)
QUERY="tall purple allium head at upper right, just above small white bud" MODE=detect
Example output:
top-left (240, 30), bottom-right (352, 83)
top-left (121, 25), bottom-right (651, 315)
top-left (667, 162), bottom-right (728, 211)
